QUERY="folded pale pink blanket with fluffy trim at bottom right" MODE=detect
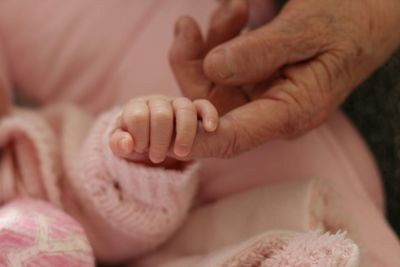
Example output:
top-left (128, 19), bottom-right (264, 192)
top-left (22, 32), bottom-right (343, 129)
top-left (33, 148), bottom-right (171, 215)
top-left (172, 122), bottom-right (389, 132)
top-left (132, 179), bottom-right (360, 267)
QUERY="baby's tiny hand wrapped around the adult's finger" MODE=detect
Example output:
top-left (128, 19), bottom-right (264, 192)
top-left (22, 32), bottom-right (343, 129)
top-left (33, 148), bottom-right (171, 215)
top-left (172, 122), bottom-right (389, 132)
top-left (110, 96), bottom-right (218, 164)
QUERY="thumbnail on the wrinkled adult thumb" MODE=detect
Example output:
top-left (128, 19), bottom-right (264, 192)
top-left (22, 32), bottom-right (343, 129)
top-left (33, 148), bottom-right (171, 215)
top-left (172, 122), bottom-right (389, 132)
top-left (210, 49), bottom-right (235, 80)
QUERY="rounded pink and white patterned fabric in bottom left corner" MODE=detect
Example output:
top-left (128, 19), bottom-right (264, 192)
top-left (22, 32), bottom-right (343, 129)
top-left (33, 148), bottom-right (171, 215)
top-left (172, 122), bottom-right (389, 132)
top-left (0, 199), bottom-right (94, 267)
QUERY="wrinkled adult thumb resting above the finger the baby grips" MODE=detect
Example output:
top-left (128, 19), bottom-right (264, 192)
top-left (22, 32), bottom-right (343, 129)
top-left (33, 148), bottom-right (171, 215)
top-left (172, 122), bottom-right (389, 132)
top-left (203, 5), bottom-right (326, 85)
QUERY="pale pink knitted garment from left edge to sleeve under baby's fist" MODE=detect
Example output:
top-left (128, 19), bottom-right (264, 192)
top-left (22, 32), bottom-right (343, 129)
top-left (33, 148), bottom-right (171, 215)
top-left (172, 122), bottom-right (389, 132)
top-left (0, 105), bottom-right (197, 262)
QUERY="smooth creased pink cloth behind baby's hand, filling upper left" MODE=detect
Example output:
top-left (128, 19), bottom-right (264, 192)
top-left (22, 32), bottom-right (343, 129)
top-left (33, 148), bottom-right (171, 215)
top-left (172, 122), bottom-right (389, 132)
top-left (0, 0), bottom-right (216, 112)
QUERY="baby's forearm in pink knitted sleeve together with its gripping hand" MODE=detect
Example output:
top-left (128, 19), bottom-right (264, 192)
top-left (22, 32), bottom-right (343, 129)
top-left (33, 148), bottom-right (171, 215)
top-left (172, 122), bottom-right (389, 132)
top-left (65, 96), bottom-right (218, 262)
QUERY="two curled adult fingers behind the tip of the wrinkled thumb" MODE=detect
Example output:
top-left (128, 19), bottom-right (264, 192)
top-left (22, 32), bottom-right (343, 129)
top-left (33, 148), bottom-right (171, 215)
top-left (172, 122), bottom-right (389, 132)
top-left (169, 0), bottom-right (248, 99)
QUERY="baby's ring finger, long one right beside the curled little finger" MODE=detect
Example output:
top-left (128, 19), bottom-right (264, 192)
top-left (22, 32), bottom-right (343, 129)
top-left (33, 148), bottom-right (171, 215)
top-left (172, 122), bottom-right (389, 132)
top-left (173, 97), bottom-right (197, 157)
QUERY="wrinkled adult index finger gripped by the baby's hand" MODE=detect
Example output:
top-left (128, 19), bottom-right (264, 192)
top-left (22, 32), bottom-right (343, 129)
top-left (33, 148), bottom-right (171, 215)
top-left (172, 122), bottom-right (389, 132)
top-left (190, 52), bottom-right (356, 158)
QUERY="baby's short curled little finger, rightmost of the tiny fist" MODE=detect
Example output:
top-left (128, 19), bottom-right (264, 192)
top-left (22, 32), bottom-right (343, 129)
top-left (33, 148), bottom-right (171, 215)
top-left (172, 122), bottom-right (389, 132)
top-left (193, 99), bottom-right (219, 132)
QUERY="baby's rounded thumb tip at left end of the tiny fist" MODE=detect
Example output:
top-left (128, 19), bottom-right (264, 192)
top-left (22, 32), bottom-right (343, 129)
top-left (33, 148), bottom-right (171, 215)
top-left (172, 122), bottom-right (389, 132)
top-left (110, 129), bottom-right (135, 158)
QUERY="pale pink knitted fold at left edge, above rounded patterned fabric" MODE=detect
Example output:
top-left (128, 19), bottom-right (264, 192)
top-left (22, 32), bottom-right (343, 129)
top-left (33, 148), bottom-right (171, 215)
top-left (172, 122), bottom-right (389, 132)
top-left (0, 109), bottom-right (61, 206)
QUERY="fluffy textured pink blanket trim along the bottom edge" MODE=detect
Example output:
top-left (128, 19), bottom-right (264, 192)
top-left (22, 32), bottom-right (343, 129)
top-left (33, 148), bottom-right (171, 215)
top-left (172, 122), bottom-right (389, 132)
top-left (136, 231), bottom-right (359, 267)
